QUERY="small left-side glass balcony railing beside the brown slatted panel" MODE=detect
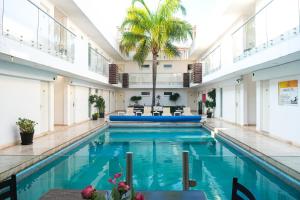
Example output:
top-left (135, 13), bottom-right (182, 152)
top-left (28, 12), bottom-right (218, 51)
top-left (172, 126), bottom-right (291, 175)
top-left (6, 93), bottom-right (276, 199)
top-left (89, 47), bottom-right (109, 77)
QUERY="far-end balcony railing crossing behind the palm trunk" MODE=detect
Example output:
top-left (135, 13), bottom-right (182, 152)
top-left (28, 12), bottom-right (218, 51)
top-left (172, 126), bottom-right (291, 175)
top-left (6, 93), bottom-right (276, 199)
top-left (129, 73), bottom-right (183, 87)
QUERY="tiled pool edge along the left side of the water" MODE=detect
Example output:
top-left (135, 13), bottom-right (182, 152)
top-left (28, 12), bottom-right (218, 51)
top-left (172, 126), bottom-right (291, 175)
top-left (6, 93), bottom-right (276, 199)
top-left (0, 122), bottom-right (108, 181)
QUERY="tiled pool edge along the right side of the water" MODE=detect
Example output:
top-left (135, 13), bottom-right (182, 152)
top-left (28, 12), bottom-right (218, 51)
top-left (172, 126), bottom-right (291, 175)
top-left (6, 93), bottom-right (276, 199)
top-left (203, 124), bottom-right (300, 190)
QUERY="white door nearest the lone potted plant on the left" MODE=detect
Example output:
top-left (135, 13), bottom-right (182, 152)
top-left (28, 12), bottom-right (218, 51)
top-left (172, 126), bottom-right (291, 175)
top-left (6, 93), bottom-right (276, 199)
top-left (40, 82), bottom-right (49, 132)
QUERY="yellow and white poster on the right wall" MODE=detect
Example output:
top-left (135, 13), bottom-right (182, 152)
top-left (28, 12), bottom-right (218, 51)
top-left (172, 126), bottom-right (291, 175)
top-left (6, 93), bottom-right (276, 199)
top-left (278, 80), bottom-right (298, 105)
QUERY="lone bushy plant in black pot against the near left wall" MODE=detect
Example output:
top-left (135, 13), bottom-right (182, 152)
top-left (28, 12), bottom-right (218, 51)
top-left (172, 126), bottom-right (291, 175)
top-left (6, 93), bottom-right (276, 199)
top-left (16, 118), bottom-right (37, 145)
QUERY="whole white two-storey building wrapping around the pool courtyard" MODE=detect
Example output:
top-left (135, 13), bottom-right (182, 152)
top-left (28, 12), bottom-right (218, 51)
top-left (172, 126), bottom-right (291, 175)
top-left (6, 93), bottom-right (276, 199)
top-left (0, 0), bottom-right (300, 148)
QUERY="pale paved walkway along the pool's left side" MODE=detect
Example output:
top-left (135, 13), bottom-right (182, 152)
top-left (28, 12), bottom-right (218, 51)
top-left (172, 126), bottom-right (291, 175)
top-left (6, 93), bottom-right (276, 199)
top-left (0, 119), bottom-right (105, 181)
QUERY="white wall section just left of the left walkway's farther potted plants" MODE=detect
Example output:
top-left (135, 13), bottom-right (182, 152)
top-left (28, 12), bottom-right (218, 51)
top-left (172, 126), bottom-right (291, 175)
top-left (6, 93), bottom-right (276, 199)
top-left (75, 86), bottom-right (89, 123)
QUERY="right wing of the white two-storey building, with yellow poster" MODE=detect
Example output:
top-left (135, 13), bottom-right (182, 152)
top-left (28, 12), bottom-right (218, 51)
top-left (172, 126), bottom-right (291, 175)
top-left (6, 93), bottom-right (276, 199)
top-left (191, 0), bottom-right (300, 144)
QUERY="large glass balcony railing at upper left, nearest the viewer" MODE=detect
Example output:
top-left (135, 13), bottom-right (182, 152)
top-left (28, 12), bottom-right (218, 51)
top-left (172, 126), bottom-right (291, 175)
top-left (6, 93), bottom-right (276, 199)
top-left (0, 0), bottom-right (76, 62)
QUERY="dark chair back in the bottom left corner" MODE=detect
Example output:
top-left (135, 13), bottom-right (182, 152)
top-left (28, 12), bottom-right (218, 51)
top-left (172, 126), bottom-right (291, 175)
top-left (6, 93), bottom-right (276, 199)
top-left (0, 175), bottom-right (17, 200)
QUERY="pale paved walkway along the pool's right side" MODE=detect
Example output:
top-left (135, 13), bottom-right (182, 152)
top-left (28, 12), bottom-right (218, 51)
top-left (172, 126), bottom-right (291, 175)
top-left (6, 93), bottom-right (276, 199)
top-left (205, 119), bottom-right (300, 180)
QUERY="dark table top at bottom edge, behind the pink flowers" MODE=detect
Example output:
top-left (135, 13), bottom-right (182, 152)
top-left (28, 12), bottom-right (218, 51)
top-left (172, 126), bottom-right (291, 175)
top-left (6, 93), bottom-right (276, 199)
top-left (41, 189), bottom-right (206, 200)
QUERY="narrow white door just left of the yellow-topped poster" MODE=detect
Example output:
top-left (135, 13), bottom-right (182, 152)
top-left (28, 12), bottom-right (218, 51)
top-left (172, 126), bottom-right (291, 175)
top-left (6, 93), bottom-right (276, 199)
top-left (261, 81), bottom-right (270, 132)
